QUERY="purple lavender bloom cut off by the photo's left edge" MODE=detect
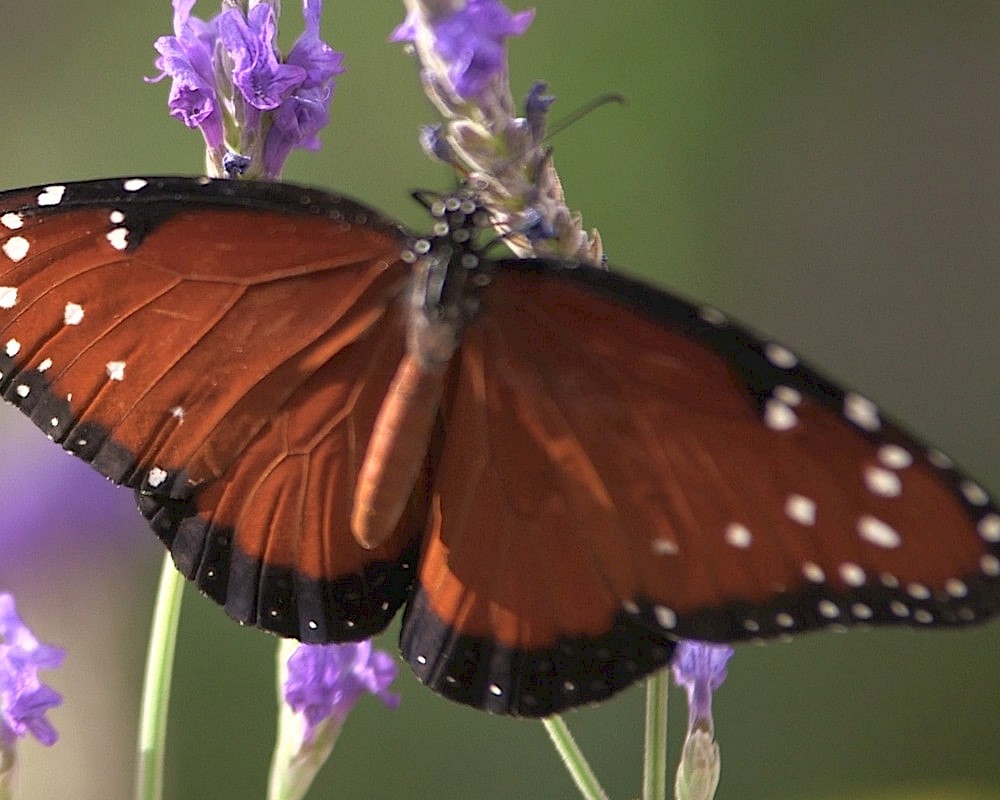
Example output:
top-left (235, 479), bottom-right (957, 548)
top-left (0, 592), bottom-right (65, 750)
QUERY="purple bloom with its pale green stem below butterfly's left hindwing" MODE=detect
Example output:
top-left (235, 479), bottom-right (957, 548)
top-left (268, 641), bottom-right (399, 800)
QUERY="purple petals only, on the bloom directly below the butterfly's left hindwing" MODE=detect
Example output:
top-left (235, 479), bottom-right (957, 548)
top-left (284, 641), bottom-right (399, 743)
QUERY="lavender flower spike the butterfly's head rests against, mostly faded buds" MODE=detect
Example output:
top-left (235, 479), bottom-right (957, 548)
top-left (391, 0), bottom-right (603, 264)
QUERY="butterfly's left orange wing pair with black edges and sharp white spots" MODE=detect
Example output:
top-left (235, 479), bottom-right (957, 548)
top-left (0, 179), bottom-right (424, 641)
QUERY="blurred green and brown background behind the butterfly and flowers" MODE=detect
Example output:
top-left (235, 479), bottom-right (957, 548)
top-left (0, 0), bottom-right (1000, 800)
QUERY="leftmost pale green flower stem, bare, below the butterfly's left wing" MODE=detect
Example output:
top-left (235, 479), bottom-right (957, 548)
top-left (135, 553), bottom-right (184, 800)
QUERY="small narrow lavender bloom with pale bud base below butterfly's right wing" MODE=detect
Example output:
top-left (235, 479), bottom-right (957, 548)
top-left (672, 641), bottom-right (733, 800)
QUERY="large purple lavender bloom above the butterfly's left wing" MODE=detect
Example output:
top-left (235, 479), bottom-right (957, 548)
top-left (152, 0), bottom-right (343, 179)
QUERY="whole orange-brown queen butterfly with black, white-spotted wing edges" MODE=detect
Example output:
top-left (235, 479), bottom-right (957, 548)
top-left (0, 178), bottom-right (1000, 716)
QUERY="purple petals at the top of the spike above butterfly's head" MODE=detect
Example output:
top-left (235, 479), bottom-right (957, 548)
top-left (390, 0), bottom-right (535, 100)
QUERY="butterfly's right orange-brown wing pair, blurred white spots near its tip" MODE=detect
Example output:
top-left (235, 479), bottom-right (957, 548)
top-left (403, 261), bottom-right (1000, 715)
